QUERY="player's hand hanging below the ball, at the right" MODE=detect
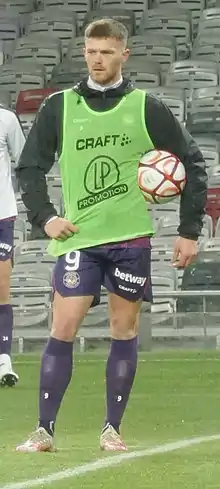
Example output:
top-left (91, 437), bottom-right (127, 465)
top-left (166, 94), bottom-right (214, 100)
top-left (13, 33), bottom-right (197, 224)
top-left (172, 236), bottom-right (198, 268)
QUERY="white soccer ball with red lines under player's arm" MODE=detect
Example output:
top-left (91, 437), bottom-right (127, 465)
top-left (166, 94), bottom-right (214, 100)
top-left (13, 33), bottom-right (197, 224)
top-left (138, 149), bottom-right (186, 204)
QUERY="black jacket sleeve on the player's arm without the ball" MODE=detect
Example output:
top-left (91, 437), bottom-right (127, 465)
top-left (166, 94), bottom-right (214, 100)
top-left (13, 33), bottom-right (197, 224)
top-left (16, 93), bottom-right (62, 227)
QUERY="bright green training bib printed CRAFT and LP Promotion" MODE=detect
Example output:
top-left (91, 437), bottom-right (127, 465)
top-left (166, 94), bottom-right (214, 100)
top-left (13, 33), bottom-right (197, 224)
top-left (48, 89), bottom-right (154, 256)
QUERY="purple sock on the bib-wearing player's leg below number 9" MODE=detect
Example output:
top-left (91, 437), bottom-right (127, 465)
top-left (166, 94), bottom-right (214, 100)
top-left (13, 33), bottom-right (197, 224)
top-left (39, 337), bottom-right (73, 435)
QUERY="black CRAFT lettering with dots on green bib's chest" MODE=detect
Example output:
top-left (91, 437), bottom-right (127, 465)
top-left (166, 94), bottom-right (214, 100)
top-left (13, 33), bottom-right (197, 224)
top-left (76, 134), bottom-right (131, 151)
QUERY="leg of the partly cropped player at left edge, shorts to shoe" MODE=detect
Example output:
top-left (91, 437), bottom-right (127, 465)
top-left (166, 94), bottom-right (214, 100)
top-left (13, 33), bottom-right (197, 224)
top-left (0, 220), bottom-right (18, 387)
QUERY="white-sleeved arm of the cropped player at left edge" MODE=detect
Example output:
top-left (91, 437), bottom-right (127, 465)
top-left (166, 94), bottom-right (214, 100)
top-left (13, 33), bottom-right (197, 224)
top-left (7, 111), bottom-right (25, 165)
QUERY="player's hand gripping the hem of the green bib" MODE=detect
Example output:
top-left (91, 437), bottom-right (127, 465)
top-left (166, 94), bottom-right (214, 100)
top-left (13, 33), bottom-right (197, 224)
top-left (44, 217), bottom-right (79, 240)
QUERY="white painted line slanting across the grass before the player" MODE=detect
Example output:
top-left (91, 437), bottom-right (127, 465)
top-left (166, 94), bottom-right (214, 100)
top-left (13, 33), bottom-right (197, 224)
top-left (0, 434), bottom-right (220, 489)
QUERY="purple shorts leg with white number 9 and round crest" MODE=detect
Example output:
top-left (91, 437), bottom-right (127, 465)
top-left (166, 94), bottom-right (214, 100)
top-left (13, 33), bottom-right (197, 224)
top-left (53, 249), bottom-right (103, 306)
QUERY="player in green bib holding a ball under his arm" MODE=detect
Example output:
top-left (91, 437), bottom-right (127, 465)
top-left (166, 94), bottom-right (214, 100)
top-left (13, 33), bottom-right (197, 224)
top-left (17, 19), bottom-right (207, 452)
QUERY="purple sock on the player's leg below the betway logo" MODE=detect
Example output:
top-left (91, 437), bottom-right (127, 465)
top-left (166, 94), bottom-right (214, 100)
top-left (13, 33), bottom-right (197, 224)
top-left (104, 337), bottom-right (137, 432)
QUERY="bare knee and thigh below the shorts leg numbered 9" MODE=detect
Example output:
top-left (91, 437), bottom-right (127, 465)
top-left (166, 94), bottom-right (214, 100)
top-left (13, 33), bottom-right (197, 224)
top-left (51, 292), bottom-right (93, 341)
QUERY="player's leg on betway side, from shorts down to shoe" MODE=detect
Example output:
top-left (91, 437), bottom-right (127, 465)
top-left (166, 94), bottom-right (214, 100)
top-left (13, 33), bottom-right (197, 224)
top-left (100, 244), bottom-right (150, 450)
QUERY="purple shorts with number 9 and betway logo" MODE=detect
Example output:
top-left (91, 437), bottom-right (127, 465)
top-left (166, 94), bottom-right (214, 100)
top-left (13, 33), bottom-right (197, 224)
top-left (53, 240), bottom-right (152, 306)
